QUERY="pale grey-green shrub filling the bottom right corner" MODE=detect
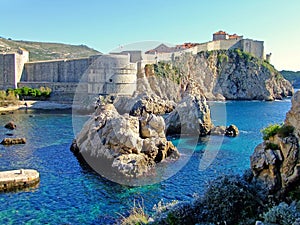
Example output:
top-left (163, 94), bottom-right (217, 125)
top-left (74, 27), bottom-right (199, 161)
top-left (263, 202), bottom-right (300, 225)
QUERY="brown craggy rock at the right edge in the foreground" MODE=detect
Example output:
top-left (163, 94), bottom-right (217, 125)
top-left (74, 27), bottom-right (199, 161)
top-left (251, 92), bottom-right (300, 197)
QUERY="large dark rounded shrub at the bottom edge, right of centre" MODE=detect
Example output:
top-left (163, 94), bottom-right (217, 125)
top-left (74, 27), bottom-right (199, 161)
top-left (202, 175), bottom-right (263, 224)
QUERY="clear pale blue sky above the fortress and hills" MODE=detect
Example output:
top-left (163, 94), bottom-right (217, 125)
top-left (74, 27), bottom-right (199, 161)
top-left (0, 0), bottom-right (300, 71)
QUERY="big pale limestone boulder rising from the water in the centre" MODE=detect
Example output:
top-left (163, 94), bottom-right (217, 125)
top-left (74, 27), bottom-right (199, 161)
top-left (71, 104), bottom-right (179, 178)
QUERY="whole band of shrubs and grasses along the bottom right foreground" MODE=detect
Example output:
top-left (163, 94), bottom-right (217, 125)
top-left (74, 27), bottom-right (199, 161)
top-left (121, 174), bottom-right (300, 225)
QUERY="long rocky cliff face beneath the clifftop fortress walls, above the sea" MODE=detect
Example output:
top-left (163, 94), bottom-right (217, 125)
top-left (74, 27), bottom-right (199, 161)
top-left (139, 50), bottom-right (293, 100)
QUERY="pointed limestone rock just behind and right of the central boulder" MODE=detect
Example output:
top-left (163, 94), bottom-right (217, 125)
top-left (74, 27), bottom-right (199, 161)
top-left (166, 94), bottom-right (213, 136)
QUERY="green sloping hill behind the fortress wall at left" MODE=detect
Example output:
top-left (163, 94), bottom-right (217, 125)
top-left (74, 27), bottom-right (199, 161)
top-left (0, 38), bottom-right (101, 61)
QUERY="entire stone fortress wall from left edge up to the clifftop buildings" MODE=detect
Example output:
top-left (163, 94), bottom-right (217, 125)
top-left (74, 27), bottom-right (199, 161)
top-left (0, 31), bottom-right (264, 101)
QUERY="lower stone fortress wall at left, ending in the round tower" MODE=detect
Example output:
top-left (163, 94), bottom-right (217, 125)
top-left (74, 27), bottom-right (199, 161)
top-left (0, 51), bottom-right (137, 102)
